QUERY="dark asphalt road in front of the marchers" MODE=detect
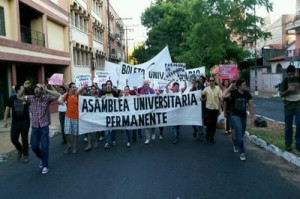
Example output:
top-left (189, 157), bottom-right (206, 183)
top-left (0, 126), bottom-right (300, 199)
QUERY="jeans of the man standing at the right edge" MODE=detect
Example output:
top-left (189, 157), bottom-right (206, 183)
top-left (284, 107), bottom-right (300, 147)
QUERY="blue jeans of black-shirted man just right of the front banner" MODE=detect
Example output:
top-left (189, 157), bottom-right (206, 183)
top-left (230, 115), bottom-right (247, 153)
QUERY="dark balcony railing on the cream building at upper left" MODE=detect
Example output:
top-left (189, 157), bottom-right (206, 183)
top-left (21, 26), bottom-right (45, 47)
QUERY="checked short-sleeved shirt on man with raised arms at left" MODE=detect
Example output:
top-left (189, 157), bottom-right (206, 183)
top-left (27, 95), bottom-right (56, 128)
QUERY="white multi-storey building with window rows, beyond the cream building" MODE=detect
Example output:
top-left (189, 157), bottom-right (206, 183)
top-left (69, 0), bottom-right (125, 80)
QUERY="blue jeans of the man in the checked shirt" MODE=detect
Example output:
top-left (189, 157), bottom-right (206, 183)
top-left (30, 126), bottom-right (49, 167)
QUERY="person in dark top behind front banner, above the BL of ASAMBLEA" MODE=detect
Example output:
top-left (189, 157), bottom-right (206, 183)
top-left (101, 80), bottom-right (119, 149)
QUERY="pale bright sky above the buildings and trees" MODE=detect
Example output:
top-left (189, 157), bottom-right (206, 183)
top-left (110, 0), bottom-right (296, 48)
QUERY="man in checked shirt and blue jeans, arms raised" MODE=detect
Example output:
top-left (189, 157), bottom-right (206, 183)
top-left (17, 81), bottom-right (59, 174)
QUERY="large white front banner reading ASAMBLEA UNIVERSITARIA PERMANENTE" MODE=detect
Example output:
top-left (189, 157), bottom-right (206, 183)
top-left (79, 91), bottom-right (202, 134)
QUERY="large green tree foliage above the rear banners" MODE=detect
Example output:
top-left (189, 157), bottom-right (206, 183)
top-left (133, 0), bottom-right (272, 72)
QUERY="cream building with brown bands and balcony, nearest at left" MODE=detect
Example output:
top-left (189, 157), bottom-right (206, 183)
top-left (0, 0), bottom-right (71, 118)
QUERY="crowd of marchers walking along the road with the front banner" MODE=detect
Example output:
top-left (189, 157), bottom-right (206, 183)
top-left (4, 76), bottom-right (254, 174)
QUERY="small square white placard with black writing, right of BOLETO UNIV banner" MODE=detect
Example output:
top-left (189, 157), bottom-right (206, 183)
top-left (165, 63), bottom-right (186, 81)
